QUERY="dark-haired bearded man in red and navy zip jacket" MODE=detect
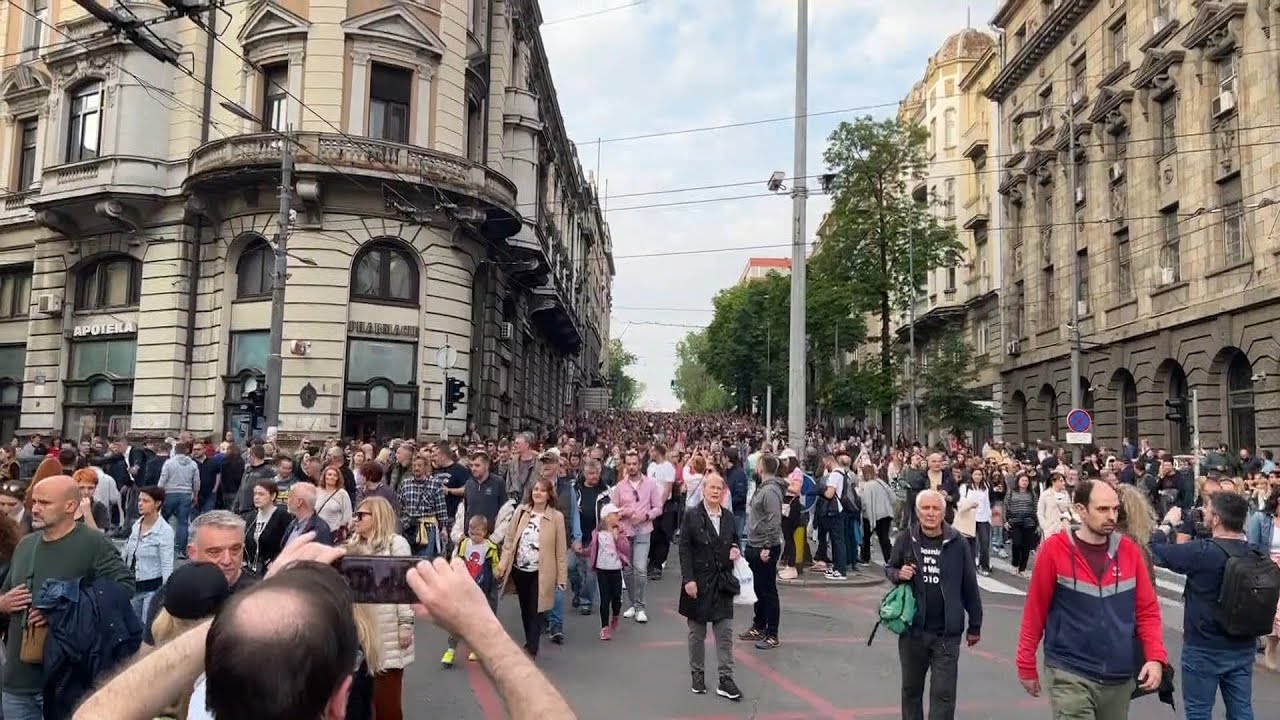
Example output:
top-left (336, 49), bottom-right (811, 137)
top-left (1018, 480), bottom-right (1169, 720)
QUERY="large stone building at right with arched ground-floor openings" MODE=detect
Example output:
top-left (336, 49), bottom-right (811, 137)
top-left (987, 0), bottom-right (1280, 451)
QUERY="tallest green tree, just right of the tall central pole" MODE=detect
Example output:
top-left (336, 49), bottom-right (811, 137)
top-left (812, 118), bottom-right (964, 427)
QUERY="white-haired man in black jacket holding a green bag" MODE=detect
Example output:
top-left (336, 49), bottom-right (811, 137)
top-left (884, 489), bottom-right (982, 720)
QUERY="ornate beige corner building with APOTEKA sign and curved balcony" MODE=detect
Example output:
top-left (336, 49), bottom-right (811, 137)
top-left (0, 0), bottom-right (613, 441)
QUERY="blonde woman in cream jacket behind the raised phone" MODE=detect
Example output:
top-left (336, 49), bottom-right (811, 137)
top-left (347, 497), bottom-right (413, 720)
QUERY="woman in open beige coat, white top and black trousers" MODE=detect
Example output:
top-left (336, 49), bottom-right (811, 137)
top-left (498, 478), bottom-right (568, 657)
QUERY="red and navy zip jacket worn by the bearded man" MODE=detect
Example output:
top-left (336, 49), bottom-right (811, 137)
top-left (1018, 530), bottom-right (1169, 683)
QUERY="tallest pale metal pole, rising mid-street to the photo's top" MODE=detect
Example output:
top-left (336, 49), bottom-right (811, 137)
top-left (787, 0), bottom-right (809, 454)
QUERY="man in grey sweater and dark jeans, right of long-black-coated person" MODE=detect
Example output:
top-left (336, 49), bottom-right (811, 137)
top-left (739, 454), bottom-right (787, 650)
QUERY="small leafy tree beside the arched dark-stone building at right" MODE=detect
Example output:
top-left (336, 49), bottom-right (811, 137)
top-left (922, 333), bottom-right (995, 437)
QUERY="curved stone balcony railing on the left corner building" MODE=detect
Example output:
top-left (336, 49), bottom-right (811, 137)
top-left (187, 132), bottom-right (518, 210)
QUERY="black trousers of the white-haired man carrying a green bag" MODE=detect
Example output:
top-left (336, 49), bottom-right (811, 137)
top-left (897, 630), bottom-right (960, 720)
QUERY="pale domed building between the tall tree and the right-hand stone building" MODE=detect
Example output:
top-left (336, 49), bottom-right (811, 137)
top-left (896, 28), bottom-right (1002, 442)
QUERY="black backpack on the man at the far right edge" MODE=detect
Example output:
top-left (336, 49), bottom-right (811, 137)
top-left (1210, 539), bottom-right (1280, 638)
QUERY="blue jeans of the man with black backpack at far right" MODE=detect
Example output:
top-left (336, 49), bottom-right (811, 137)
top-left (1181, 644), bottom-right (1254, 720)
